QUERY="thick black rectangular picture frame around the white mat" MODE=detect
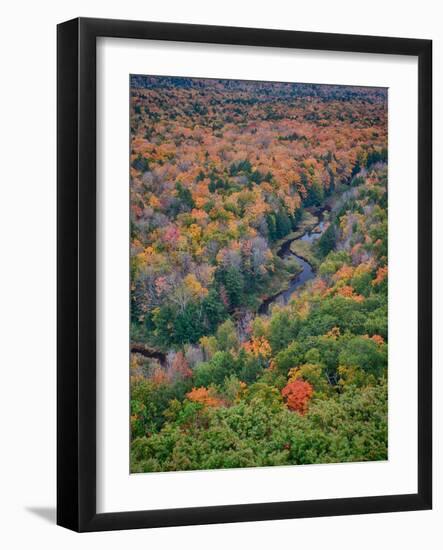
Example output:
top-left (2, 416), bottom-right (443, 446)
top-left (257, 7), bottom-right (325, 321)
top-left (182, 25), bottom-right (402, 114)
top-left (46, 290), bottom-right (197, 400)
top-left (57, 18), bottom-right (432, 532)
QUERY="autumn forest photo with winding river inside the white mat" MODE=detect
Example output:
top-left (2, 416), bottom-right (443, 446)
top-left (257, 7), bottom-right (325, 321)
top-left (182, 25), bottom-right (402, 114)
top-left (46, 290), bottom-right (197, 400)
top-left (129, 75), bottom-right (388, 473)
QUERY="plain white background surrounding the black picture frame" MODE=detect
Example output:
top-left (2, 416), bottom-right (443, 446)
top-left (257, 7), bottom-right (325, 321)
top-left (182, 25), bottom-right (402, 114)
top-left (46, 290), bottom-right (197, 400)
top-left (0, 0), bottom-right (443, 550)
